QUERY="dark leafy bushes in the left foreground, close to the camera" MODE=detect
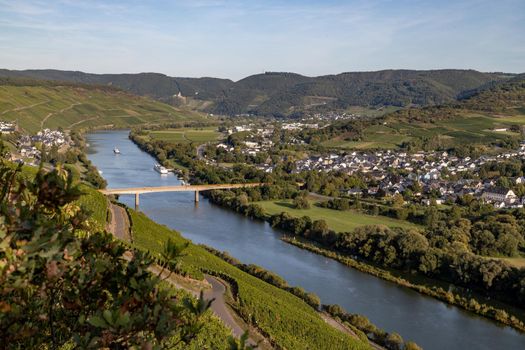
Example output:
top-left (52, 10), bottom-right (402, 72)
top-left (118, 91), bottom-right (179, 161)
top-left (0, 161), bottom-right (215, 349)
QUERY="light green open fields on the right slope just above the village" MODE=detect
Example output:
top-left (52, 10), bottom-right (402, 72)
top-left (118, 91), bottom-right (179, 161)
top-left (323, 113), bottom-right (525, 149)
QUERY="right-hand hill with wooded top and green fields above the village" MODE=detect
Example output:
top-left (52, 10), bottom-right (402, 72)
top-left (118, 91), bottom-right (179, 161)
top-left (316, 74), bottom-right (525, 154)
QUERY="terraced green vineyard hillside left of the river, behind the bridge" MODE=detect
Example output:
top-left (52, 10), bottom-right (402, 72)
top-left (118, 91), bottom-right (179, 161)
top-left (0, 85), bottom-right (204, 133)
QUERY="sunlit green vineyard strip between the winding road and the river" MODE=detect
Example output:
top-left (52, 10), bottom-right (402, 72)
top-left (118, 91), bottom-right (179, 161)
top-left (130, 210), bottom-right (368, 349)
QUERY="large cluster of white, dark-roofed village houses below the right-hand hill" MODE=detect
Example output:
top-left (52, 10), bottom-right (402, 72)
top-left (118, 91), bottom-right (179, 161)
top-left (295, 142), bottom-right (525, 208)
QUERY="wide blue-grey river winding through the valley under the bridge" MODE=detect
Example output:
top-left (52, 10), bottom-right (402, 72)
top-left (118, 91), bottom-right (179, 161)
top-left (86, 130), bottom-right (525, 350)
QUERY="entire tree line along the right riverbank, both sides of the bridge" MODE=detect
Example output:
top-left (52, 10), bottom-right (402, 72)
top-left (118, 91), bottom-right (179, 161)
top-left (126, 128), bottom-right (525, 331)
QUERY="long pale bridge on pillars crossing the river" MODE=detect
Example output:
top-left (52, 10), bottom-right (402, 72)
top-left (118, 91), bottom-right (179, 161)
top-left (99, 182), bottom-right (264, 208)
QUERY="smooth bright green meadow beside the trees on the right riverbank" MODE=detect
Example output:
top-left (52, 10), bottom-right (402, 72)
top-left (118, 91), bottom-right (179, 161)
top-left (256, 200), bottom-right (418, 232)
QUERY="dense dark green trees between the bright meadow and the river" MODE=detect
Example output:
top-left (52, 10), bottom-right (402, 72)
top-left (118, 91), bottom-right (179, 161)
top-left (269, 212), bottom-right (525, 307)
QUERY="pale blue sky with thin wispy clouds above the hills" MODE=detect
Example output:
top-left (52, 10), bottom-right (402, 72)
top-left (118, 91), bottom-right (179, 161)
top-left (0, 0), bottom-right (525, 80)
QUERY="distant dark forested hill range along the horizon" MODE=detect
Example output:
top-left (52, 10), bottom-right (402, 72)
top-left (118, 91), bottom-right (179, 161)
top-left (0, 69), bottom-right (512, 116)
